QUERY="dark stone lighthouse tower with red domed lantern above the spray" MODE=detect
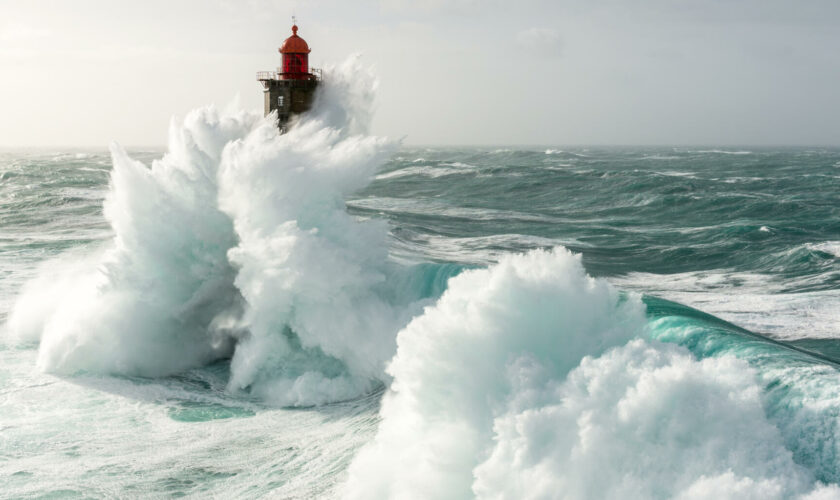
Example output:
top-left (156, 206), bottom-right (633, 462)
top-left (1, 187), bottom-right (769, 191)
top-left (257, 24), bottom-right (321, 134)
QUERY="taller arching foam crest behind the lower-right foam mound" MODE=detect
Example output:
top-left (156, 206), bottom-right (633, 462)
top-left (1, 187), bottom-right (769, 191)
top-left (348, 248), bottom-right (645, 498)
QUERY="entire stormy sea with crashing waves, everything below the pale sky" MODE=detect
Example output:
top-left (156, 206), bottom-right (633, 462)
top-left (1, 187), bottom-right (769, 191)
top-left (0, 65), bottom-right (840, 498)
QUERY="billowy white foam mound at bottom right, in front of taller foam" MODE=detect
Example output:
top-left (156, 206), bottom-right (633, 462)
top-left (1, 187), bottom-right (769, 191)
top-left (473, 340), bottom-right (828, 499)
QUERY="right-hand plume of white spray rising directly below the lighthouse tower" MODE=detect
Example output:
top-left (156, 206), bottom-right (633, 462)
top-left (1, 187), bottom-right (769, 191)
top-left (219, 61), bottom-right (422, 405)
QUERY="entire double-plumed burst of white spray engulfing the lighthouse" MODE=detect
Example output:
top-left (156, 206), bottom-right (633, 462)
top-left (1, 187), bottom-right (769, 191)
top-left (10, 58), bottom-right (448, 405)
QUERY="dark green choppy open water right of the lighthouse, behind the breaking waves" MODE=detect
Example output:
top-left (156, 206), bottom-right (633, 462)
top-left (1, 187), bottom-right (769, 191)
top-left (356, 147), bottom-right (840, 339)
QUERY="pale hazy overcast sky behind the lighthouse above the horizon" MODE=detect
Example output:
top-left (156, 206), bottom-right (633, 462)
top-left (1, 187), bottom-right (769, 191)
top-left (0, 0), bottom-right (840, 148)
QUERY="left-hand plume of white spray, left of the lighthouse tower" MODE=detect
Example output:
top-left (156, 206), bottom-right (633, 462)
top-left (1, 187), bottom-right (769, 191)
top-left (10, 108), bottom-right (260, 376)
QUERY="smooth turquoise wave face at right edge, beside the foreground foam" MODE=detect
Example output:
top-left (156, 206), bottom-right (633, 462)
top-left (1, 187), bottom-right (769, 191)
top-left (645, 297), bottom-right (840, 483)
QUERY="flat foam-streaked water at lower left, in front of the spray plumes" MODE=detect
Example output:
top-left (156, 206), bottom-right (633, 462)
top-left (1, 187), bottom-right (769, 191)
top-left (0, 349), bottom-right (376, 499)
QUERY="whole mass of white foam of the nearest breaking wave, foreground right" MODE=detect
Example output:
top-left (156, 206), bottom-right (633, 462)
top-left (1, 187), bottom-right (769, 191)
top-left (344, 249), bottom-right (840, 499)
